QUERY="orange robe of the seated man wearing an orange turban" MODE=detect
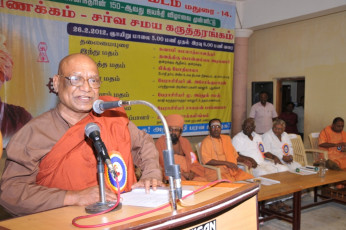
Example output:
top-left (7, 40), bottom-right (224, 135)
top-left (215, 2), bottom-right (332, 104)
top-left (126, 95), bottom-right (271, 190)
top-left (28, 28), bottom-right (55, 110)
top-left (156, 136), bottom-right (217, 181)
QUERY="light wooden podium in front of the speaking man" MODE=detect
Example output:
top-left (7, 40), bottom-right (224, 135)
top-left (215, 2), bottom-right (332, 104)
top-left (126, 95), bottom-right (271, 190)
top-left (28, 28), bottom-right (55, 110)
top-left (0, 182), bottom-right (259, 230)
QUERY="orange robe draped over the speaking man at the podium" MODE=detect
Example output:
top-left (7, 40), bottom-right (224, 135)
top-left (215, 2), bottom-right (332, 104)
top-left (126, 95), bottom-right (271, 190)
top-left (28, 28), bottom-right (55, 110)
top-left (36, 97), bottom-right (136, 191)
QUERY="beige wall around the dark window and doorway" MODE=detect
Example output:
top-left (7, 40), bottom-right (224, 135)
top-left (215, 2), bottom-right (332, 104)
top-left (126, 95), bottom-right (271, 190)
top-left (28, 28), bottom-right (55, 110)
top-left (247, 11), bottom-right (346, 146)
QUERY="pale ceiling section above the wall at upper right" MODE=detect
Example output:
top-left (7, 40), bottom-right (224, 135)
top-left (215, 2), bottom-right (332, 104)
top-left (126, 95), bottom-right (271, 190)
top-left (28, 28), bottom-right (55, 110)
top-left (223, 0), bottom-right (346, 30)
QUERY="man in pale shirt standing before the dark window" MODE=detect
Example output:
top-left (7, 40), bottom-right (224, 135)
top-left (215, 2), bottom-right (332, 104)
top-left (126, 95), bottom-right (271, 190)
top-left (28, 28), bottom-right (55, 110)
top-left (249, 91), bottom-right (278, 134)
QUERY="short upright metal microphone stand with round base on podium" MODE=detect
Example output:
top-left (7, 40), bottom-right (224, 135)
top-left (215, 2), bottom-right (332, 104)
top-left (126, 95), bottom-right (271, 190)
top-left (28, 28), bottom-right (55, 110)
top-left (85, 154), bottom-right (122, 214)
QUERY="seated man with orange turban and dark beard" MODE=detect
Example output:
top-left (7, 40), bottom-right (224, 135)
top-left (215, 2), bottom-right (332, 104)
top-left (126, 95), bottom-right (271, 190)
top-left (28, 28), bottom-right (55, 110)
top-left (156, 114), bottom-right (217, 181)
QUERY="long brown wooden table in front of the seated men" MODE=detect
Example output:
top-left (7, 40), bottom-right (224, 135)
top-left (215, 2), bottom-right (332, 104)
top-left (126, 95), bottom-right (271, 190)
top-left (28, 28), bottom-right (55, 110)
top-left (258, 170), bottom-right (346, 230)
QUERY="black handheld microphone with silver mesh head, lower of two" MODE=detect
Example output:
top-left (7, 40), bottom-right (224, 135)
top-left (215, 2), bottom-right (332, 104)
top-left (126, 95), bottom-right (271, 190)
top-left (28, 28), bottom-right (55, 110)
top-left (85, 122), bottom-right (117, 178)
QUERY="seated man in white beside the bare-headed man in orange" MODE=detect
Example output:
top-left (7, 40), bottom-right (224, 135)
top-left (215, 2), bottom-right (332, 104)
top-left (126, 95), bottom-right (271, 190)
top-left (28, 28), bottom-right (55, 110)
top-left (232, 118), bottom-right (288, 177)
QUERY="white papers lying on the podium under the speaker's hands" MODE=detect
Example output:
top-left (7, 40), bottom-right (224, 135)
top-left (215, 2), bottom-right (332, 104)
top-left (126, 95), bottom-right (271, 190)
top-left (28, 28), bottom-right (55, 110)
top-left (120, 187), bottom-right (193, 208)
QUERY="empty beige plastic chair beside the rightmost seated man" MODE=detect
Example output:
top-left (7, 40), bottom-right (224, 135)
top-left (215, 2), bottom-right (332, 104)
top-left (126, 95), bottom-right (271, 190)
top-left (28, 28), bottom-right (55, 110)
top-left (289, 134), bottom-right (328, 166)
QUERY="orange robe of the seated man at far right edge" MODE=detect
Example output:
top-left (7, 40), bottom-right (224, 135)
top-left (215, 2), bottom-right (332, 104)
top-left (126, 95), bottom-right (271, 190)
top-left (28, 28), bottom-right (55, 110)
top-left (318, 126), bottom-right (346, 170)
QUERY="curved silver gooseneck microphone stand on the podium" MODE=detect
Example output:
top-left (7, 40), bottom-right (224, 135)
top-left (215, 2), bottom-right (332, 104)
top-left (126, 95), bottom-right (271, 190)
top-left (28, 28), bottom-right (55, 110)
top-left (119, 100), bottom-right (182, 213)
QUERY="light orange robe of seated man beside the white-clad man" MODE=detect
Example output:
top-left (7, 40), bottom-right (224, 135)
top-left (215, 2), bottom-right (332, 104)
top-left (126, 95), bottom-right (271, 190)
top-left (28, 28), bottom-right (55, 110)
top-left (201, 135), bottom-right (253, 181)
